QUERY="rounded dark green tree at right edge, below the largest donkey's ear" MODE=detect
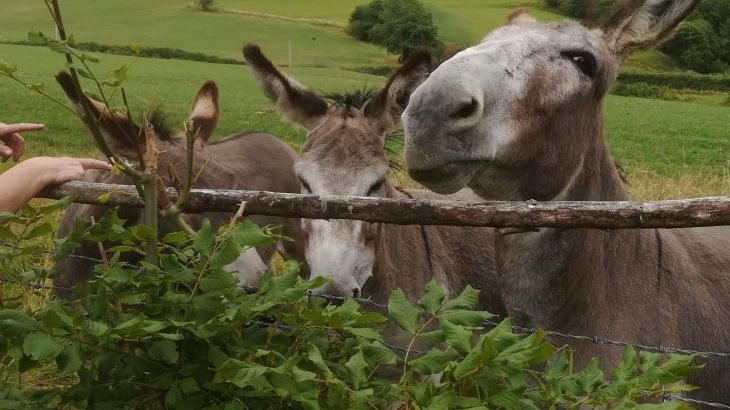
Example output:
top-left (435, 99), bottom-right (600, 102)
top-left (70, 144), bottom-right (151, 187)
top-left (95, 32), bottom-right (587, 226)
top-left (661, 18), bottom-right (725, 74)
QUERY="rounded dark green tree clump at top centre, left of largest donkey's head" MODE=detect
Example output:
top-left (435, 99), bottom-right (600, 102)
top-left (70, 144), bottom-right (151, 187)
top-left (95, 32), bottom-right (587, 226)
top-left (347, 0), bottom-right (439, 59)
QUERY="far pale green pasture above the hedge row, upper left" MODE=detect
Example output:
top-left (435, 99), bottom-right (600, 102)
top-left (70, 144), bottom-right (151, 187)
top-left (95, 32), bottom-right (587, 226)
top-left (0, 0), bottom-right (395, 67)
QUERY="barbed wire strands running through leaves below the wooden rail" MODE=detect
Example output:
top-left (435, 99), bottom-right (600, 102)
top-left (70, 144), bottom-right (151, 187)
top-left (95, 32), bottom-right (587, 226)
top-left (0, 255), bottom-right (730, 410)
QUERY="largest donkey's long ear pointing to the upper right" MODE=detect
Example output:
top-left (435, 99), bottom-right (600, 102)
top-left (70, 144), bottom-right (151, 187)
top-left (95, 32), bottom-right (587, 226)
top-left (603, 0), bottom-right (700, 60)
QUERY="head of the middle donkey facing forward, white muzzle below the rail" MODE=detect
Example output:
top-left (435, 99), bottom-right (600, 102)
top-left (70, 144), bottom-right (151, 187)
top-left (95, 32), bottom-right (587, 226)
top-left (243, 45), bottom-right (431, 296)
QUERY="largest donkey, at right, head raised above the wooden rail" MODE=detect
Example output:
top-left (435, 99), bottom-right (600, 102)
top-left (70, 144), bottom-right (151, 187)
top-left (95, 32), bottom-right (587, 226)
top-left (403, 0), bottom-right (730, 404)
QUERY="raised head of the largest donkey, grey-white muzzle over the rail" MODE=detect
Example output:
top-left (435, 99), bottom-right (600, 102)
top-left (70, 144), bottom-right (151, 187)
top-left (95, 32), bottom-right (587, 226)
top-left (403, 0), bottom-right (699, 200)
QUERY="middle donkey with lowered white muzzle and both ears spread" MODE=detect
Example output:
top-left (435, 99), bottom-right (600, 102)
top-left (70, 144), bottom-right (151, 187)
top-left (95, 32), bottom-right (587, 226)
top-left (244, 46), bottom-right (504, 313)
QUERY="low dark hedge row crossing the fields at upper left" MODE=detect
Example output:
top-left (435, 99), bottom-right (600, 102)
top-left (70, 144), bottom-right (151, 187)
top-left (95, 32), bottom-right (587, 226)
top-left (2, 40), bottom-right (246, 65)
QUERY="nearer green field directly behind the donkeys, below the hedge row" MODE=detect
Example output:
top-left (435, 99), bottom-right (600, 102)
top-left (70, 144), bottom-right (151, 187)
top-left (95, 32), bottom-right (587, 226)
top-left (0, 45), bottom-right (730, 199)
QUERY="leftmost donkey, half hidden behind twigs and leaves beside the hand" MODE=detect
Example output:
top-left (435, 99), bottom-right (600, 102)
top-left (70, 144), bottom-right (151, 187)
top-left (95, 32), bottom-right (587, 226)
top-left (55, 73), bottom-right (303, 287)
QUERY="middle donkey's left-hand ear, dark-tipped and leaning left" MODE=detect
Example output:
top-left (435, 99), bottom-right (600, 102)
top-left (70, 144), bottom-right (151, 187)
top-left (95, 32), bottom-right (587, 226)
top-left (243, 44), bottom-right (327, 130)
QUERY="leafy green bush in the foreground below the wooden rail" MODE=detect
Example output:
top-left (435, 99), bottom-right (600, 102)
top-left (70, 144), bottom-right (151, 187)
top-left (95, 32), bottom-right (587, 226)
top-left (0, 205), bottom-right (696, 409)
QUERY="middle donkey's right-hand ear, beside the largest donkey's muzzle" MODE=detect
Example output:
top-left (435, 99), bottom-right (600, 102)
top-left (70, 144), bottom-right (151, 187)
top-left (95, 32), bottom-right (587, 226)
top-left (363, 49), bottom-right (432, 131)
